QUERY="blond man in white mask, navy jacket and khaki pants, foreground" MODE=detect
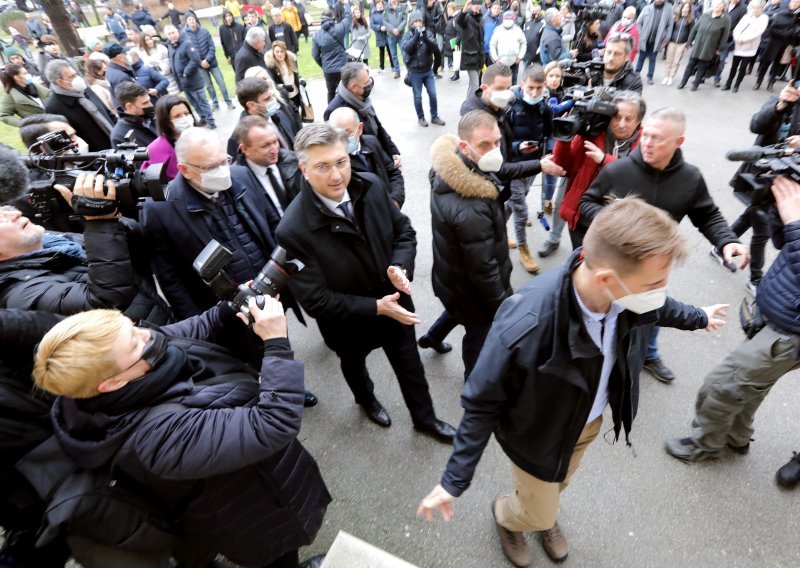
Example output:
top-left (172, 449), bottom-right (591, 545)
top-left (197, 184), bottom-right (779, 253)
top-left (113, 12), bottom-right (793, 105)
top-left (417, 198), bottom-right (726, 566)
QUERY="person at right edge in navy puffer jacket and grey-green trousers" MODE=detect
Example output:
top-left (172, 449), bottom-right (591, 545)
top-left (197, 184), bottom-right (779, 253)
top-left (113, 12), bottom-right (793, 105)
top-left (666, 178), bottom-right (800, 487)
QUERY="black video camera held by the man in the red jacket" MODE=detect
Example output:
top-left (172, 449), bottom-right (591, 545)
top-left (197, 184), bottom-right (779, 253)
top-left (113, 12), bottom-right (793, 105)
top-left (553, 86), bottom-right (617, 141)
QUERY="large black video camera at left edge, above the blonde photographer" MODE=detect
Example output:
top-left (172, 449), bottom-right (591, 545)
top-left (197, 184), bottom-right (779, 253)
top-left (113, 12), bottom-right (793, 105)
top-left (23, 130), bottom-right (167, 219)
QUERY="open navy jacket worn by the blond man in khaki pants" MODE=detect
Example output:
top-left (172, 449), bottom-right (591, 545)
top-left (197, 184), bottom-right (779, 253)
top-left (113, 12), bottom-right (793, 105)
top-left (441, 250), bottom-right (708, 496)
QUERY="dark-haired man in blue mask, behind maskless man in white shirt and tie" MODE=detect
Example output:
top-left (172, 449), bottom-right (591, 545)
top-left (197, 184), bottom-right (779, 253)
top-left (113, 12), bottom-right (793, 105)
top-left (228, 77), bottom-right (303, 156)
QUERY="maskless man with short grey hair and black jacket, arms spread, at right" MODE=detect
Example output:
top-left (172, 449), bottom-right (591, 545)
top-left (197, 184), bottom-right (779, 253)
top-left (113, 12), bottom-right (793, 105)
top-left (581, 108), bottom-right (749, 382)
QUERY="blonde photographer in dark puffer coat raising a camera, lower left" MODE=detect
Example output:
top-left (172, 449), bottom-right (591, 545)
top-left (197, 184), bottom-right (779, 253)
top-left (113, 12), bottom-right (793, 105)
top-left (25, 297), bottom-right (331, 568)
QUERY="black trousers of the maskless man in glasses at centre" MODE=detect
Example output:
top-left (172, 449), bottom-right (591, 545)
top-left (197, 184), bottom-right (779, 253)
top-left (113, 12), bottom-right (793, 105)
top-left (336, 321), bottom-right (436, 428)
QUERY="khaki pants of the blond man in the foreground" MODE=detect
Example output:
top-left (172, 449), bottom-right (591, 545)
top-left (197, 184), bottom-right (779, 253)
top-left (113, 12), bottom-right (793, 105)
top-left (496, 417), bottom-right (603, 532)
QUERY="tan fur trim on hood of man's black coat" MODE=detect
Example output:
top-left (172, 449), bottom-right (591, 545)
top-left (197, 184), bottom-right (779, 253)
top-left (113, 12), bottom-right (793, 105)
top-left (431, 134), bottom-right (500, 199)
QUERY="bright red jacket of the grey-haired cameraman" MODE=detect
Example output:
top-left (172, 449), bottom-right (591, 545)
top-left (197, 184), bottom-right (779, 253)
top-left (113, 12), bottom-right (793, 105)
top-left (553, 131), bottom-right (639, 230)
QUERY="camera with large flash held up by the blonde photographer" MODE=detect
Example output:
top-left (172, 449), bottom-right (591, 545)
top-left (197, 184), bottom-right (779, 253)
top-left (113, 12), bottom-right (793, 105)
top-left (192, 240), bottom-right (305, 317)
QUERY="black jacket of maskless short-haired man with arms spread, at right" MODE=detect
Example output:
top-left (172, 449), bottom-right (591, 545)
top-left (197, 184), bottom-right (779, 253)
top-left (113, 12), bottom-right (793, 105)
top-left (581, 148), bottom-right (739, 250)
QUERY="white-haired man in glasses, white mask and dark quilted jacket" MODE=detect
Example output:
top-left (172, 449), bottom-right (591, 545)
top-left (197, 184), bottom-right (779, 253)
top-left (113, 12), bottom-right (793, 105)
top-left (142, 128), bottom-right (316, 406)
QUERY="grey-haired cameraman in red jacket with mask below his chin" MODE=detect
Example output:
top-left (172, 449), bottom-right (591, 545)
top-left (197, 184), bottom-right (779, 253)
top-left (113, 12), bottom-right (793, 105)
top-left (543, 91), bottom-right (647, 250)
